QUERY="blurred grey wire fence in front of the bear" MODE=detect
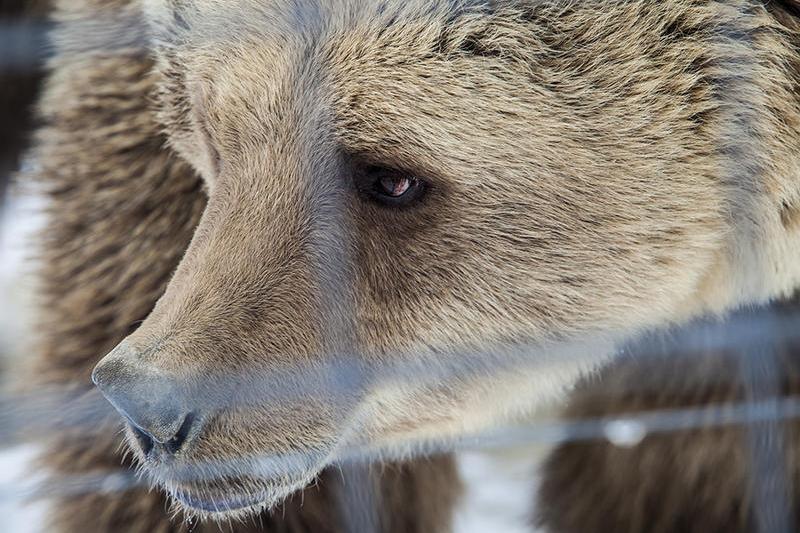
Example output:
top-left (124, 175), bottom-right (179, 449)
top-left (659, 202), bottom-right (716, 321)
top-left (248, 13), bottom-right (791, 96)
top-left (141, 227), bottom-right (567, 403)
top-left (0, 1), bottom-right (800, 533)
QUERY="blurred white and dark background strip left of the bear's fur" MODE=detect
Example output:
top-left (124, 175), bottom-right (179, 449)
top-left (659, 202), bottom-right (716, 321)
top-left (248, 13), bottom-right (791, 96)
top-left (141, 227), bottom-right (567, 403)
top-left (0, 0), bottom-right (58, 533)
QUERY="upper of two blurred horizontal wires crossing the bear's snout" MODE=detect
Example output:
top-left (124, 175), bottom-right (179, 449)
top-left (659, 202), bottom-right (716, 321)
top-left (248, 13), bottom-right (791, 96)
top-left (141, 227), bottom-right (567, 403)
top-left (0, 311), bottom-right (800, 445)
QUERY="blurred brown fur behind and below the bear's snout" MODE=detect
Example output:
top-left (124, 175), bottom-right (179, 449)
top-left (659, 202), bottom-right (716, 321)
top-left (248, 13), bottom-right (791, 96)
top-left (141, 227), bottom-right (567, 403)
top-left (26, 2), bottom-right (458, 533)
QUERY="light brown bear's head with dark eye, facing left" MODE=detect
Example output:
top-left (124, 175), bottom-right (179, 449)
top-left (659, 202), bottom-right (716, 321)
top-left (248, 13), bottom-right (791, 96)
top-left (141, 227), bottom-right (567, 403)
top-left (87, 0), bottom-right (800, 517)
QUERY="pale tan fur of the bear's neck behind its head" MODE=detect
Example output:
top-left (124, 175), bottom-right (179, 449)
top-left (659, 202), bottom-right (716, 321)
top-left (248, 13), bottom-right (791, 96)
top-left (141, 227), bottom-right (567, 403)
top-left (686, 6), bottom-right (800, 314)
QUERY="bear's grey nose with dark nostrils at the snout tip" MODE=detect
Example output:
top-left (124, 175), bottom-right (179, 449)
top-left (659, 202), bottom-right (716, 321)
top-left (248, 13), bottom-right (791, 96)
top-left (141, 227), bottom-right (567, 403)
top-left (92, 342), bottom-right (196, 456)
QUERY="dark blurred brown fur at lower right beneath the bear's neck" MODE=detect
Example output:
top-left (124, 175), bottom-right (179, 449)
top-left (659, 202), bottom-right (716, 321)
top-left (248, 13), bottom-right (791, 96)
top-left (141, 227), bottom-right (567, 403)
top-left (536, 301), bottom-right (800, 533)
